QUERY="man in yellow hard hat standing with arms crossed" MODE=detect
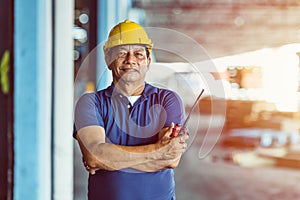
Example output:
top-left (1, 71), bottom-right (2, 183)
top-left (74, 20), bottom-right (188, 200)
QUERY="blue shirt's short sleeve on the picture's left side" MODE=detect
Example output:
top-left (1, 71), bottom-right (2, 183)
top-left (73, 93), bottom-right (104, 138)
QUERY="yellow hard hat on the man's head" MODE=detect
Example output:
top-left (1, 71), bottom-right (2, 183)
top-left (103, 20), bottom-right (153, 53)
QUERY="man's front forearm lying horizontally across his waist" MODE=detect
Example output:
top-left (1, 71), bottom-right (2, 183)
top-left (81, 140), bottom-right (180, 172)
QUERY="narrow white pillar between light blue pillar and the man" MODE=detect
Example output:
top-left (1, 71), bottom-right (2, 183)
top-left (52, 0), bottom-right (74, 200)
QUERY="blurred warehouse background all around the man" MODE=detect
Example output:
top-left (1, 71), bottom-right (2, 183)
top-left (0, 0), bottom-right (300, 200)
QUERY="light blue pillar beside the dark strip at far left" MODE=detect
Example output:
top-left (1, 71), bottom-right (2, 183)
top-left (14, 0), bottom-right (52, 200)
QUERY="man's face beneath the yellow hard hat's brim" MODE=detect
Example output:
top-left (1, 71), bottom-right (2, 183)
top-left (106, 45), bottom-right (151, 83)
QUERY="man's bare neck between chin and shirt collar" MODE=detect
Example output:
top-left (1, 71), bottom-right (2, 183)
top-left (114, 82), bottom-right (145, 96)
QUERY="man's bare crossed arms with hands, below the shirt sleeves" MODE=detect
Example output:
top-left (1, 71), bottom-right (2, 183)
top-left (77, 127), bottom-right (184, 171)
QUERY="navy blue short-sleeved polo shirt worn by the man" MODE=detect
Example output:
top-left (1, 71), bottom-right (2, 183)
top-left (74, 83), bottom-right (184, 200)
